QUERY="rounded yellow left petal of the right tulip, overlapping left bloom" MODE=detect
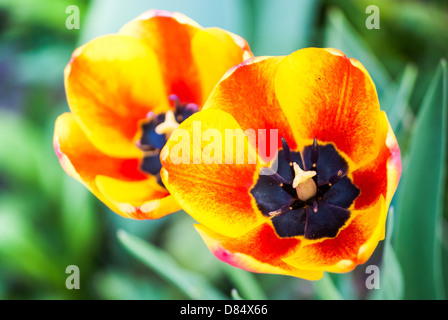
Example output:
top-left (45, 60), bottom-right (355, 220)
top-left (161, 110), bottom-right (266, 236)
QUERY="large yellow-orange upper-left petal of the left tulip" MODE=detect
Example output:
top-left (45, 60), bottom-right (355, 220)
top-left (65, 35), bottom-right (169, 158)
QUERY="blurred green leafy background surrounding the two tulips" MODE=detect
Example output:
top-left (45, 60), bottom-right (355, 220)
top-left (0, 0), bottom-right (448, 300)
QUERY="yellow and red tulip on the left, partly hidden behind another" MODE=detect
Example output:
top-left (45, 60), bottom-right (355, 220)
top-left (54, 10), bottom-right (252, 219)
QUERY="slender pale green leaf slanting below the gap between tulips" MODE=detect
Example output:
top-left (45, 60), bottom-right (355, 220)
top-left (117, 230), bottom-right (227, 300)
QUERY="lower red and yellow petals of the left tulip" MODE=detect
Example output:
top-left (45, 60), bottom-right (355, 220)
top-left (54, 113), bottom-right (180, 219)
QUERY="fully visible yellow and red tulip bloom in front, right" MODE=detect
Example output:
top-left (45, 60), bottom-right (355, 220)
top-left (160, 48), bottom-right (401, 280)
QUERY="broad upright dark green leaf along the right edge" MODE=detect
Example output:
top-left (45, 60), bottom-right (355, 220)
top-left (395, 61), bottom-right (447, 299)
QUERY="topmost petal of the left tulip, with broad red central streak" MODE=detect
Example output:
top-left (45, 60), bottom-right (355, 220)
top-left (120, 10), bottom-right (252, 106)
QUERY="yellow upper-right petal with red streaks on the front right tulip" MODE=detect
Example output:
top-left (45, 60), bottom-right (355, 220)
top-left (275, 48), bottom-right (387, 168)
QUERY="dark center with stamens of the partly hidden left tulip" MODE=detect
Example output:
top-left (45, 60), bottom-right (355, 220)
top-left (137, 95), bottom-right (199, 186)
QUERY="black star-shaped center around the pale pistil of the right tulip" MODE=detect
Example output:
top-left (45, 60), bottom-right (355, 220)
top-left (251, 139), bottom-right (360, 240)
